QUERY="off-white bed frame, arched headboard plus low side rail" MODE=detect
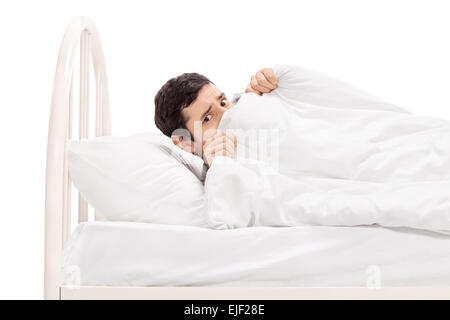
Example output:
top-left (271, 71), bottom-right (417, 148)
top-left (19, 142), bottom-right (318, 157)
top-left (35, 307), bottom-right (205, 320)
top-left (44, 17), bottom-right (450, 300)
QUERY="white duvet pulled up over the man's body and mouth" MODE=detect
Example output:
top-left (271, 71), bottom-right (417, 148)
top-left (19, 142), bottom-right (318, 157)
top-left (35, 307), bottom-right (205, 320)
top-left (205, 65), bottom-right (450, 230)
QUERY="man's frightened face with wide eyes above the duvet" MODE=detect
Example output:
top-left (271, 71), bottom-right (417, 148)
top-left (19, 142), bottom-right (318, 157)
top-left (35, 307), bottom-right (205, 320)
top-left (181, 83), bottom-right (234, 153)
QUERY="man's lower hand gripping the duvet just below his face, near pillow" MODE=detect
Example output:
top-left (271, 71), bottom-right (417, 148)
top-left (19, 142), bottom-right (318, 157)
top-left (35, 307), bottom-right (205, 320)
top-left (203, 131), bottom-right (237, 167)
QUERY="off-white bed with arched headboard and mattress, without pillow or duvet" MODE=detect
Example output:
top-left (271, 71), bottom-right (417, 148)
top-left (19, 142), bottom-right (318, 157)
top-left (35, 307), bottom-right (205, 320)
top-left (44, 17), bottom-right (450, 299)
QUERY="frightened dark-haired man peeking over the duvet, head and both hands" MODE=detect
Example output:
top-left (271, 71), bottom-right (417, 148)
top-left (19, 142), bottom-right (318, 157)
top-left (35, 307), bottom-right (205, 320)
top-left (155, 68), bottom-right (278, 167)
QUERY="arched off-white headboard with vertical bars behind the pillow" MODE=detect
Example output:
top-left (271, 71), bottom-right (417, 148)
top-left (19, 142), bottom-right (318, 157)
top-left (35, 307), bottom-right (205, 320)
top-left (44, 17), bottom-right (111, 299)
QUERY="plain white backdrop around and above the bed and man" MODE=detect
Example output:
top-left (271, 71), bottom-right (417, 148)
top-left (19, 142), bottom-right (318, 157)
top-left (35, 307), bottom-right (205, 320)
top-left (0, 0), bottom-right (450, 299)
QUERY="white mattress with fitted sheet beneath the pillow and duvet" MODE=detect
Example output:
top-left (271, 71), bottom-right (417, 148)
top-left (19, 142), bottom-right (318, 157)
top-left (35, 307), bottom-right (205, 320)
top-left (63, 222), bottom-right (450, 287)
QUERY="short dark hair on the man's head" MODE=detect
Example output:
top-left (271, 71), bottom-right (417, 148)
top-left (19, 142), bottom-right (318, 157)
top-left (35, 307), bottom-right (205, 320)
top-left (155, 73), bottom-right (212, 137)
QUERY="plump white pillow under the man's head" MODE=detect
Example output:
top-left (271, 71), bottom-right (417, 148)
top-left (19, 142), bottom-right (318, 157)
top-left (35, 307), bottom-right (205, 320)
top-left (68, 133), bottom-right (207, 227)
